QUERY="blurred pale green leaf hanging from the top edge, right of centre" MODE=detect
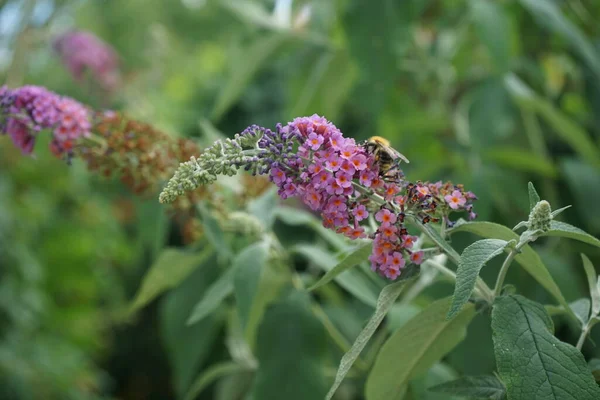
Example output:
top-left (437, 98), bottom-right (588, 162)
top-left (469, 0), bottom-right (511, 72)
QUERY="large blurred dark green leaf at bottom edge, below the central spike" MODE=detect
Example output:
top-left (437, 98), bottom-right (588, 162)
top-left (159, 256), bottom-right (223, 397)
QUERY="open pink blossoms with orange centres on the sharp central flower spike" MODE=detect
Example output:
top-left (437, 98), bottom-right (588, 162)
top-left (270, 115), bottom-right (434, 280)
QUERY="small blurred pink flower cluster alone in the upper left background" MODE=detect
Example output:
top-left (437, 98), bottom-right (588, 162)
top-left (54, 31), bottom-right (121, 92)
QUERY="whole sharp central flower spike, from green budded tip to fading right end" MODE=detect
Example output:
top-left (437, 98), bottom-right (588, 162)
top-left (160, 115), bottom-right (475, 280)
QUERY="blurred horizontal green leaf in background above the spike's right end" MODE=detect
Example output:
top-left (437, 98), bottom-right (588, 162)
top-left (483, 146), bottom-right (558, 178)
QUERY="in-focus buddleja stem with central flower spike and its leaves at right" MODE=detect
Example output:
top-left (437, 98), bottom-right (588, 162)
top-left (160, 116), bottom-right (600, 400)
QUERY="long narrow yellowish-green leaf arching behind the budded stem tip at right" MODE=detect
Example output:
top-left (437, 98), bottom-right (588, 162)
top-left (448, 221), bottom-right (577, 321)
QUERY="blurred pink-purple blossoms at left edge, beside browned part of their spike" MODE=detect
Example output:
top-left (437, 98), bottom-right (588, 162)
top-left (0, 86), bottom-right (91, 156)
